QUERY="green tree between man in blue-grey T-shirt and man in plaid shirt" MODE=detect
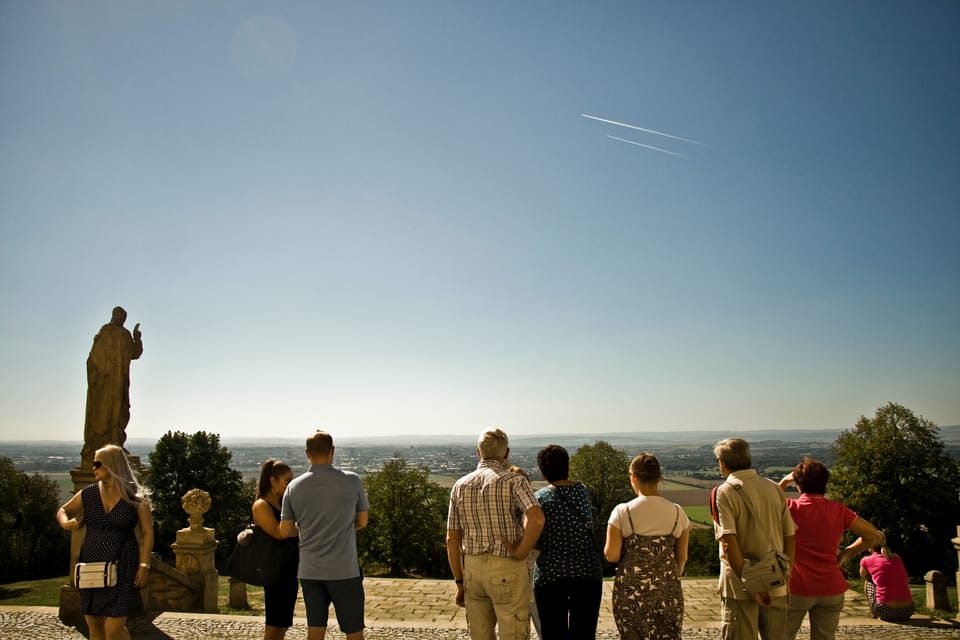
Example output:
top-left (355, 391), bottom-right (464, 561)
top-left (357, 457), bottom-right (450, 577)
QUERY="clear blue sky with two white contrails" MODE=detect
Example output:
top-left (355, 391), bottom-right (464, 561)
top-left (0, 0), bottom-right (960, 441)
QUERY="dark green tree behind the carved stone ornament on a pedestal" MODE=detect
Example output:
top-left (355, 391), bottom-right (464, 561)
top-left (147, 431), bottom-right (255, 567)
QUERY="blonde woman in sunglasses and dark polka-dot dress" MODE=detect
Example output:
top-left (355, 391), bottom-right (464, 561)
top-left (57, 445), bottom-right (153, 640)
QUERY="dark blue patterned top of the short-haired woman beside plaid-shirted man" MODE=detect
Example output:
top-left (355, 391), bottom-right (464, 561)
top-left (533, 482), bottom-right (603, 586)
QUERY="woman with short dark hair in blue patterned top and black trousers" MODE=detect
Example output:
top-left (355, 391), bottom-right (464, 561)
top-left (533, 444), bottom-right (603, 640)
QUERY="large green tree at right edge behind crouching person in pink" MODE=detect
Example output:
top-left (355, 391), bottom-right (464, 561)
top-left (829, 403), bottom-right (960, 576)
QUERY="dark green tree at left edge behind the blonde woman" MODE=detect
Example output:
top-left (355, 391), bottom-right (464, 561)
top-left (0, 458), bottom-right (70, 582)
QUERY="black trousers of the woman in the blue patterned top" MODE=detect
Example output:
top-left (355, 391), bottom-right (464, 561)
top-left (533, 578), bottom-right (603, 640)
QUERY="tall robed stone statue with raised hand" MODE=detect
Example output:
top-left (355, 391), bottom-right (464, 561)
top-left (80, 307), bottom-right (143, 468)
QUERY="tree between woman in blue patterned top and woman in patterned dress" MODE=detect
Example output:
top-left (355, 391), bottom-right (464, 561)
top-left (570, 440), bottom-right (636, 568)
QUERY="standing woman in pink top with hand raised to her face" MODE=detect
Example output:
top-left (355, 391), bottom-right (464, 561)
top-left (780, 457), bottom-right (882, 640)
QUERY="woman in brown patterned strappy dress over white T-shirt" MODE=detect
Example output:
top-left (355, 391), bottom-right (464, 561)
top-left (603, 453), bottom-right (690, 640)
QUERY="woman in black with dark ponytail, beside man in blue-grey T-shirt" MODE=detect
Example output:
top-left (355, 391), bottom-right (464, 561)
top-left (253, 459), bottom-right (300, 640)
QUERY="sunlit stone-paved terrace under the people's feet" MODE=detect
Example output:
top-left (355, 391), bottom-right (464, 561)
top-left (0, 578), bottom-right (960, 640)
